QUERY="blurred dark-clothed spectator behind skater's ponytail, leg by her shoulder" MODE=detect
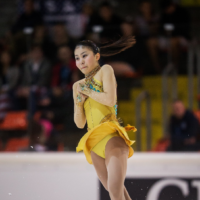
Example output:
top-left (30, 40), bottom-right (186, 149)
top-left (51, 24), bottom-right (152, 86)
top-left (106, 19), bottom-right (143, 77)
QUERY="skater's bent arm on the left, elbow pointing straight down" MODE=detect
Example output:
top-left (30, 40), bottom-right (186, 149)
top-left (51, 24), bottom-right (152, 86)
top-left (73, 82), bottom-right (87, 128)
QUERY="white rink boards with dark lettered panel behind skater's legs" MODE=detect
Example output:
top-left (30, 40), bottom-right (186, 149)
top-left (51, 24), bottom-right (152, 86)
top-left (0, 152), bottom-right (200, 200)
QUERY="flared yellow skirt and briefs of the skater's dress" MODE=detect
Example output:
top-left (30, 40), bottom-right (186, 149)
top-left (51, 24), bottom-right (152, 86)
top-left (76, 121), bottom-right (137, 164)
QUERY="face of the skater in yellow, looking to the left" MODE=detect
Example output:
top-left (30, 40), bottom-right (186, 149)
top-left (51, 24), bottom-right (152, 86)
top-left (74, 45), bottom-right (100, 74)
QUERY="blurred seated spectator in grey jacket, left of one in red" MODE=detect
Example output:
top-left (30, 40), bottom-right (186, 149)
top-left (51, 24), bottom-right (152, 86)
top-left (16, 45), bottom-right (51, 115)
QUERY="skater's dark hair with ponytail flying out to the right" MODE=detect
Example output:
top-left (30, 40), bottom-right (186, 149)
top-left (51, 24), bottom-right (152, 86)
top-left (75, 36), bottom-right (136, 57)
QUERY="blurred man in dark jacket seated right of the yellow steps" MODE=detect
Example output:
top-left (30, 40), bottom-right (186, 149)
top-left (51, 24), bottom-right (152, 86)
top-left (168, 100), bottom-right (200, 151)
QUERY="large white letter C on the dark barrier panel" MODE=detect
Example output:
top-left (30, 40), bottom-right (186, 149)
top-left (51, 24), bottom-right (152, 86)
top-left (146, 179), bottom-right (189, 200)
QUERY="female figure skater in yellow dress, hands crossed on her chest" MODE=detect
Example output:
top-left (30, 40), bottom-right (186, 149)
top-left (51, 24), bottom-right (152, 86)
top-left (73, 36), bottom-right (137, 200)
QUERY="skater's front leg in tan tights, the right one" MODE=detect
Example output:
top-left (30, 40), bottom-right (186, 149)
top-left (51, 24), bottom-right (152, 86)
top-left (105, 137), bottom-right (130, 200)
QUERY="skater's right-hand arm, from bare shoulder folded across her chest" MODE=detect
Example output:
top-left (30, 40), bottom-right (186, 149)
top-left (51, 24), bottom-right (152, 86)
top-left (78, 65), bottom-right (116, 107)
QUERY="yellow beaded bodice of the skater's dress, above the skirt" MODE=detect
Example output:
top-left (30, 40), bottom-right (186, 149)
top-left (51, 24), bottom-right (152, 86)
top-left (84, 77), bottom-right (117, 129)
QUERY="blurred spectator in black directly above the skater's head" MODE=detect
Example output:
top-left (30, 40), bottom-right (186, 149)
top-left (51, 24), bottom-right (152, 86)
top-left (87, 2), bottom-right (122, 42)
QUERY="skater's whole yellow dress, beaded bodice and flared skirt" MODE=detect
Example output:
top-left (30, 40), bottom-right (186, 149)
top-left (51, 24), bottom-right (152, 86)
top-left (76, 77), bottom-right (137, 164)
